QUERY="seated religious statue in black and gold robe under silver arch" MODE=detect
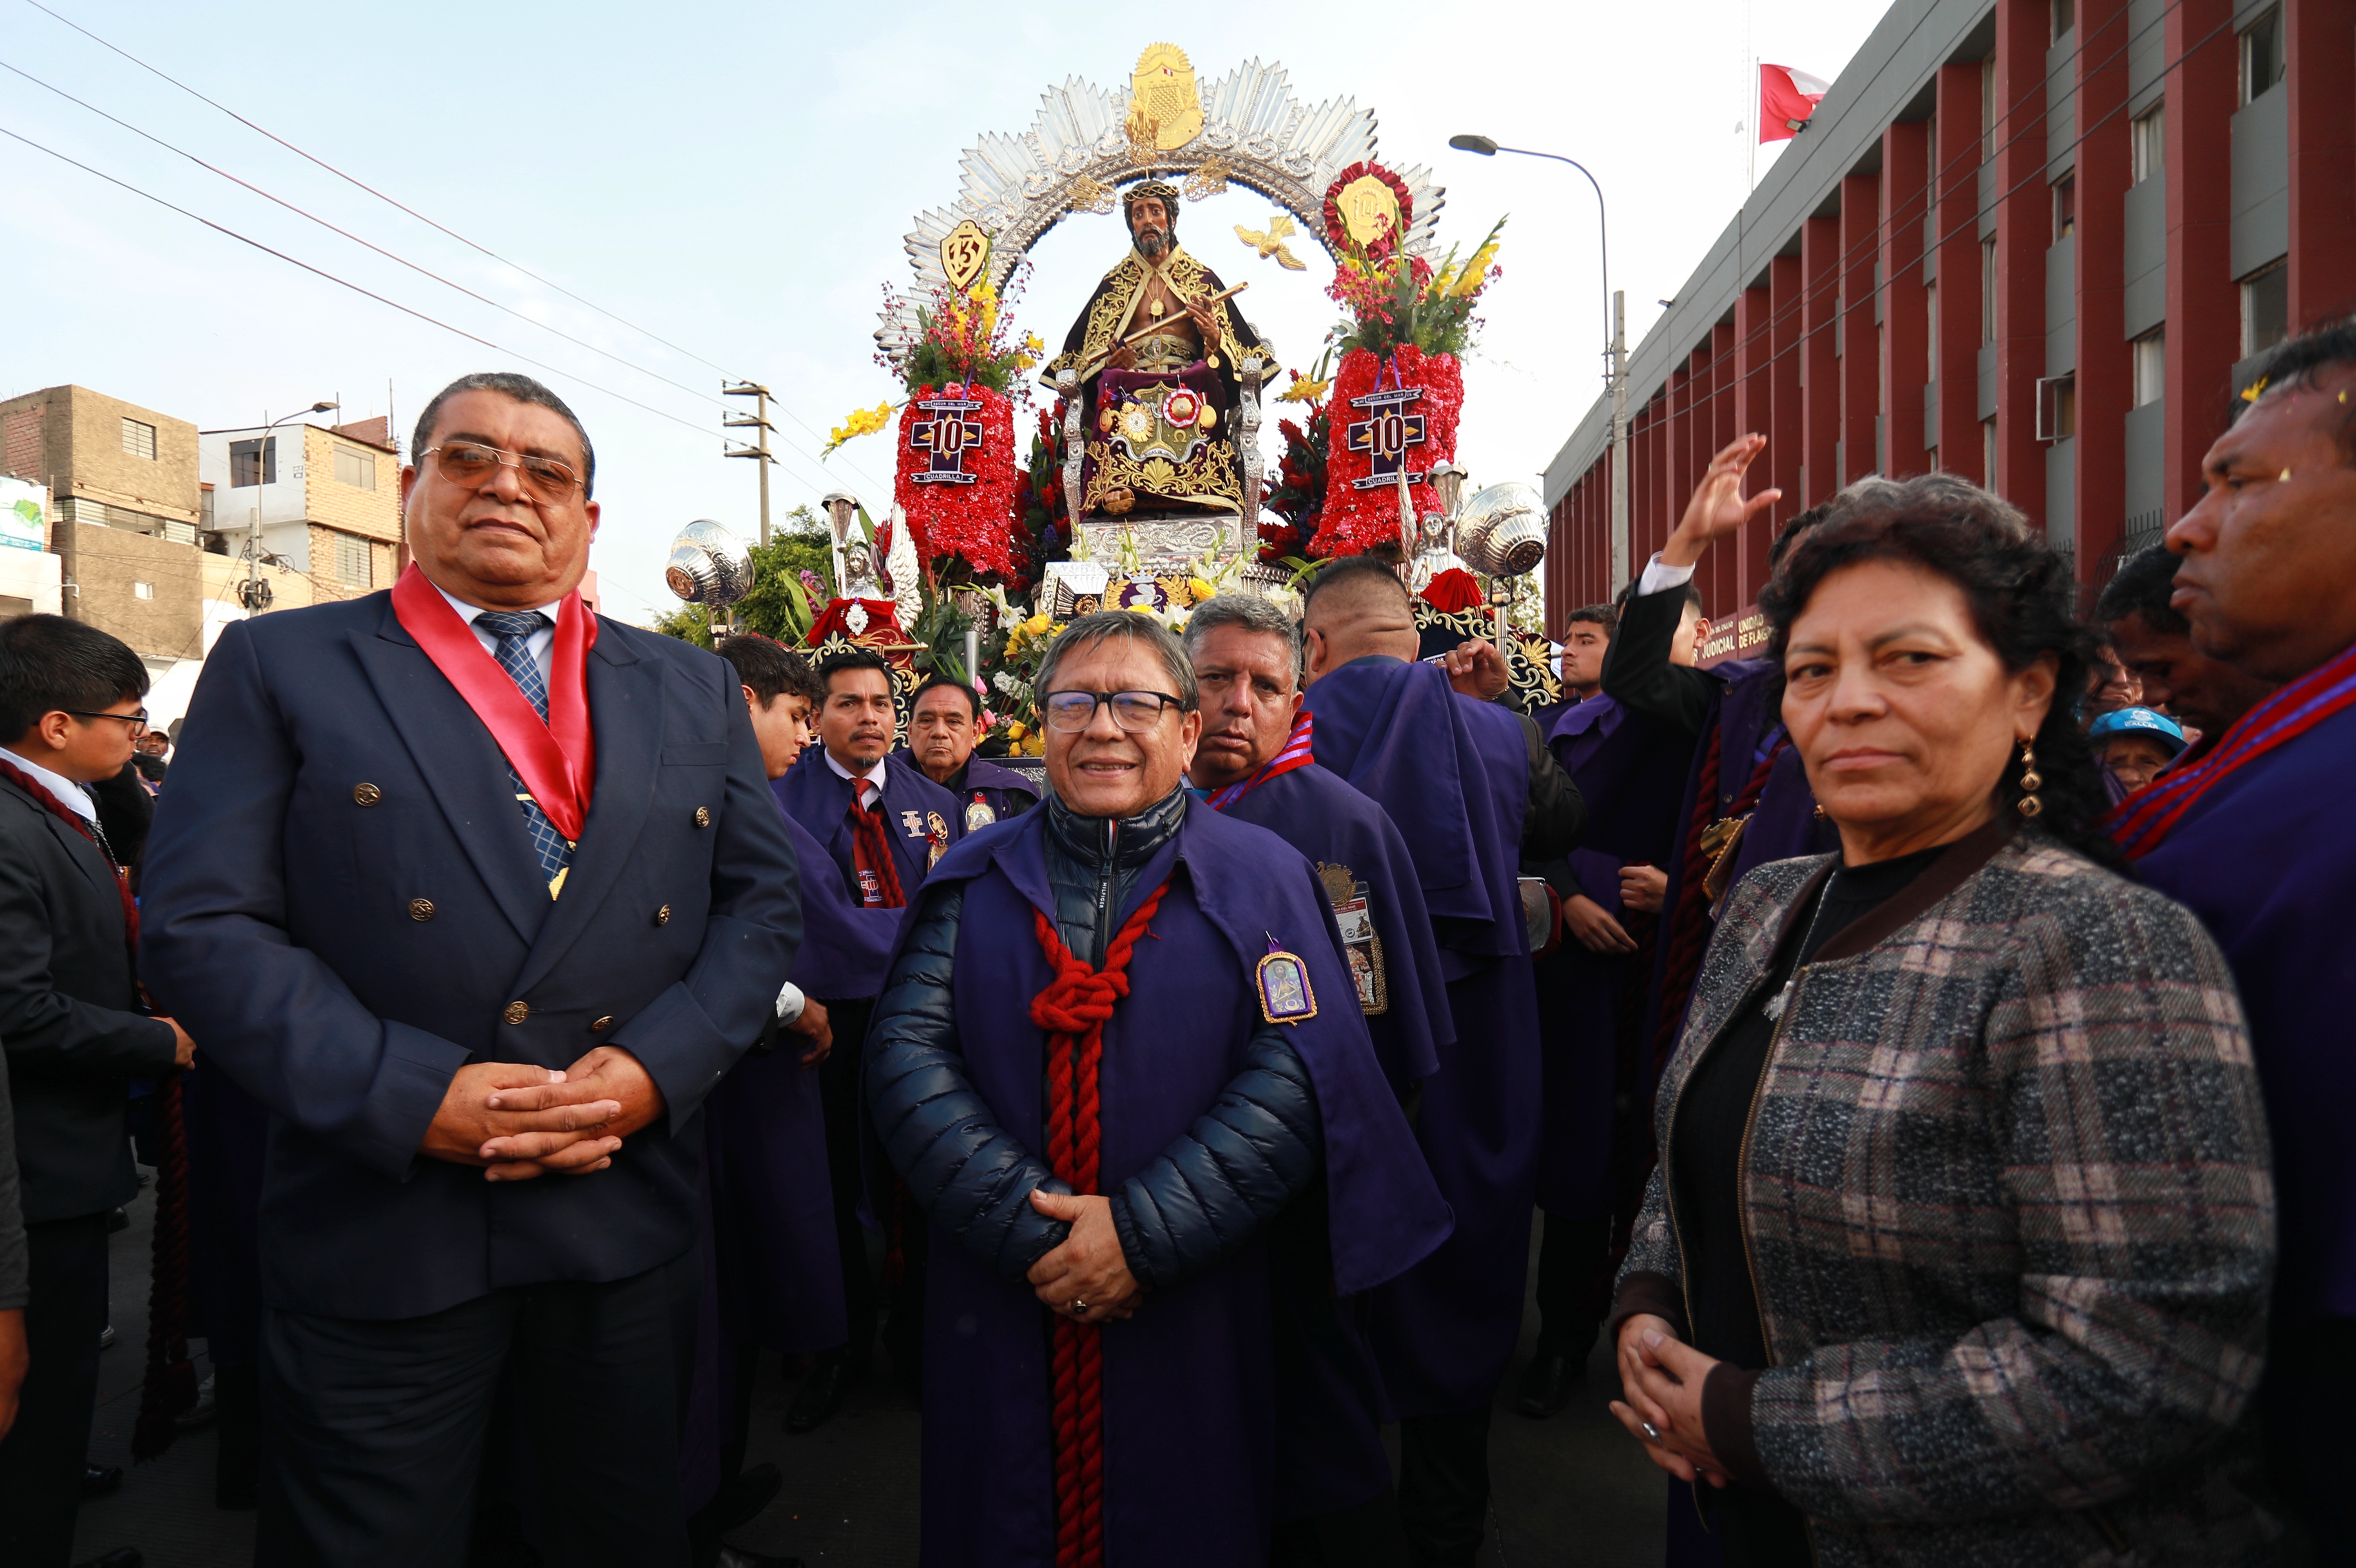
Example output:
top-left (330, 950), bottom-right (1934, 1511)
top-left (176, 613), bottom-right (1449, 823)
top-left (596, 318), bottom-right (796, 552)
top-left (1041, 179), bottom-right (1265, 518)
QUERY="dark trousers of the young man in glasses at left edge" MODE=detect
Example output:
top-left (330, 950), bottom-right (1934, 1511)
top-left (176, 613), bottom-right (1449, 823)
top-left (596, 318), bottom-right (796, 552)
top-left (0, 1215), bottom-right (106, 1568)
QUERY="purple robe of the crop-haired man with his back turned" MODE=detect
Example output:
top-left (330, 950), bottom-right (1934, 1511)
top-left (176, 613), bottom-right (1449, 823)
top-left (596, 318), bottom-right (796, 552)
top-left (1307, 657), bottom-right (1543, 1415)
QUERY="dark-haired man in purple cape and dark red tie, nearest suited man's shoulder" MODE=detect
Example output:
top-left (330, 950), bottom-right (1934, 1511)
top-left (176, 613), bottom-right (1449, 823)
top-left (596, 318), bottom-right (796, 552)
top-left (773, 648), bottom-right (966, 1432)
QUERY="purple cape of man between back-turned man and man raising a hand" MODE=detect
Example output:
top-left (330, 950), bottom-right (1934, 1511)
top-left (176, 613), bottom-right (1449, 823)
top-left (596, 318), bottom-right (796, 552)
top-left (1536, 697), bottom-right (1694, 1220)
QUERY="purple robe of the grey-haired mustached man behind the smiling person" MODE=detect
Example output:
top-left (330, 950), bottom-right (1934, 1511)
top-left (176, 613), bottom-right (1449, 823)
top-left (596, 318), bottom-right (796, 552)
top-left (1223, 763), bottom-right (1456, 1519)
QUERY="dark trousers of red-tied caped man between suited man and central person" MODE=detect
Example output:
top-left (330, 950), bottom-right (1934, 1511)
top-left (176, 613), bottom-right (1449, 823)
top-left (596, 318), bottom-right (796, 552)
top-left (817, 998), bottom-right (926, 1382)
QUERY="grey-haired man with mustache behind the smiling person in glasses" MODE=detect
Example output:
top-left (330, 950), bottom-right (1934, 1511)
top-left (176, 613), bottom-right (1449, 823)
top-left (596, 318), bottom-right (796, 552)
top-left (1185, 593), bottom-right (1456, 1563)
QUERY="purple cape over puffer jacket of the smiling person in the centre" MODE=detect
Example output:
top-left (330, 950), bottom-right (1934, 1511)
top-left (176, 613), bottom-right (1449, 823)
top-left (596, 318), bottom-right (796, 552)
top-left (900, 800), bottom-right (1449, 1568)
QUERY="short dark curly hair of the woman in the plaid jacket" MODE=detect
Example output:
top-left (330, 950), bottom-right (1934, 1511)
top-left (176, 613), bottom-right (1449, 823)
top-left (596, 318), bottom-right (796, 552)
top-left (1760, 473), bottom-right (2125, 866)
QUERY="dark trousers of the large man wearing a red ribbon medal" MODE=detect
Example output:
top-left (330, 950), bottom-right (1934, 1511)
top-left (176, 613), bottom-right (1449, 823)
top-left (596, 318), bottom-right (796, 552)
top-left (254, 1252), bottom-right (695, 1568)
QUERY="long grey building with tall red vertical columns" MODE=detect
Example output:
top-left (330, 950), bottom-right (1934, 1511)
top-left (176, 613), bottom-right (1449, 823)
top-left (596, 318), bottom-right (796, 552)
top-left (1546, 0), bottom-right (2356, 657)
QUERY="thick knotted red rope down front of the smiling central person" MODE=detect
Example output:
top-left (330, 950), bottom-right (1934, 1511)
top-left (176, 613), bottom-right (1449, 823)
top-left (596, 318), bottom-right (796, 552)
top-left (1032, 880), bottom-right (1171, 1568)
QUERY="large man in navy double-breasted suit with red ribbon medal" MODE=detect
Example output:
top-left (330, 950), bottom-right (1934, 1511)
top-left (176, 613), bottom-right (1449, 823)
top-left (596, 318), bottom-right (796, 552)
top-left (144, 374), bottom-right (801, 1568)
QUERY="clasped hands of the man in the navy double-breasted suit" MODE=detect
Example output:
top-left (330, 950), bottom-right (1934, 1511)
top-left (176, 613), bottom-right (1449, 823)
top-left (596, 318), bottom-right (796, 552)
top-left (417, 1045), bottom-right (662, 1182)
